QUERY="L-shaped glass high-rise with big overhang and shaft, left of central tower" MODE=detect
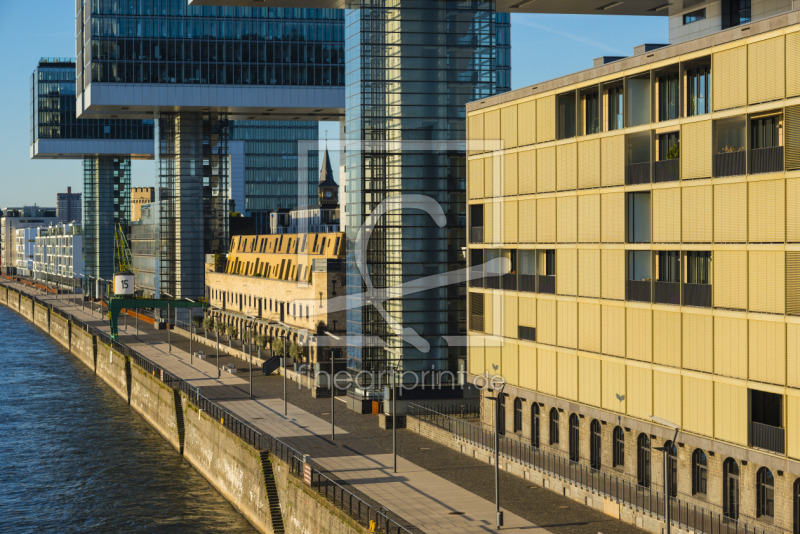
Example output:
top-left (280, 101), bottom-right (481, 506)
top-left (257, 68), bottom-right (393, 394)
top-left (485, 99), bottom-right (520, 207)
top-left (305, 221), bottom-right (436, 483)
top-left (76, 0), bottom-right (344, 297)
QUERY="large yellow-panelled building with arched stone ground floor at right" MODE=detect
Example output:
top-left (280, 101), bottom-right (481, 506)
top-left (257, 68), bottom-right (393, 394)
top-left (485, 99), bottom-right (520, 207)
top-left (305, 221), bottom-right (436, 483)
top-left (468, 11), bottom-right (800, 532)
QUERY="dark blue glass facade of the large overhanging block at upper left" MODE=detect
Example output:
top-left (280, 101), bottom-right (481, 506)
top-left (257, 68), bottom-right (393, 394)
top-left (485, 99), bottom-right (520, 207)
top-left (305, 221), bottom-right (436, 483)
top-left (76, 0), bottom-right (344, 93)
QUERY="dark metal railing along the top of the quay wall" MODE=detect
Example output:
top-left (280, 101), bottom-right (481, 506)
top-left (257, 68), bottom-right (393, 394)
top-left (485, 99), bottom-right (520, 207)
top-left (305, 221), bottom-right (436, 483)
top-left (6, 286), bottom-right (421, 534)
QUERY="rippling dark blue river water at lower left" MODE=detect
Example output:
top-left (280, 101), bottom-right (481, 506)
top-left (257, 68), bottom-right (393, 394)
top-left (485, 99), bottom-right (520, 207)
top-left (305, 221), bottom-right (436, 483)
top-left (0, 305), bottom-right (254, 533)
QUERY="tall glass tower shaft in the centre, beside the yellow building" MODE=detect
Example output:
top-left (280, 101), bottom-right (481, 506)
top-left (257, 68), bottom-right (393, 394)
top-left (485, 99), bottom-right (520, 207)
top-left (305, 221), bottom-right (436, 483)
top-left (345, 0), bottom-right (510, 371)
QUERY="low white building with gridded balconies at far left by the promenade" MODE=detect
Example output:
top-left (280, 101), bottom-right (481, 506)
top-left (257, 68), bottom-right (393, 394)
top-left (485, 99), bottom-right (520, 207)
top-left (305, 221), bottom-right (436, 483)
top-left (16, 224), bottom-right (83, 287)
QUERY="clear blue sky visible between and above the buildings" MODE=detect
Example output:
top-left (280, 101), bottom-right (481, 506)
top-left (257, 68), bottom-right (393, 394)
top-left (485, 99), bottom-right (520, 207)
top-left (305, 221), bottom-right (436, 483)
top-left (0, 0), bottom-right (667, 208)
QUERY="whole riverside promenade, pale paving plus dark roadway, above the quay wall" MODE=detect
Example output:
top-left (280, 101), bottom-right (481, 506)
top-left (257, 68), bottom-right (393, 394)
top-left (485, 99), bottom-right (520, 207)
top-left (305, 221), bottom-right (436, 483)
top-left (6, 282), bottom-right (638, 532)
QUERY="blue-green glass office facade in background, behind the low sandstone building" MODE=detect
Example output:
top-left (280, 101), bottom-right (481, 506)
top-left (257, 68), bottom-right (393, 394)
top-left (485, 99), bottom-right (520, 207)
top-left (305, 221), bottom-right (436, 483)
top-left (230, 121), bottom-right (319, 234)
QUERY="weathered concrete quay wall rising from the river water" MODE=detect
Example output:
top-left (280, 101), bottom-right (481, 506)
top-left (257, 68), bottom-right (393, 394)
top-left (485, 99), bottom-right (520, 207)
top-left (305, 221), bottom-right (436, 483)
top-left (0, 286), bottom-right (368, 534)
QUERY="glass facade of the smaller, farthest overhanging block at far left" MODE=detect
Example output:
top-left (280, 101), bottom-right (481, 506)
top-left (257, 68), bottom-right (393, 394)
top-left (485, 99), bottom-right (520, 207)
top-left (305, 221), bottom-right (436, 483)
top-left (31, 58), bottom-right (153, 144)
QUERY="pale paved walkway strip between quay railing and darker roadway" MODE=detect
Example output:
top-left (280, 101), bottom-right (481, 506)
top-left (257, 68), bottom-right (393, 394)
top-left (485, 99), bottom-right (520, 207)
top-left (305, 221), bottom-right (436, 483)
top-left (9, 284), bottom-right (548, 533)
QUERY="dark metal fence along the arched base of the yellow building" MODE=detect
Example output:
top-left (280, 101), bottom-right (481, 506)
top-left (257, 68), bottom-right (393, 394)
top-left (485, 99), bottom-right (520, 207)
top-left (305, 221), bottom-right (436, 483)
top-left (407, 404), bottom-right (784, 534)
